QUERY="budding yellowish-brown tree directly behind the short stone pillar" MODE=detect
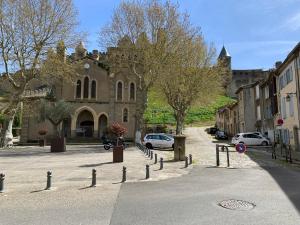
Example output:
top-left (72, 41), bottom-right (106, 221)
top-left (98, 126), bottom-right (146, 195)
top-left (158, 34), bottom-right (223, 135)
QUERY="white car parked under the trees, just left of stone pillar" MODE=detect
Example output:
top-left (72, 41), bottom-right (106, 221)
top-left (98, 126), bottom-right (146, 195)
top-left (143, 133), bottom-right (174, 149)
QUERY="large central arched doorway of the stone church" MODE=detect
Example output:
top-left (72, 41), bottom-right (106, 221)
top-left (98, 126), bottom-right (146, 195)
top-left (76, 110), bottom-right (94, 137)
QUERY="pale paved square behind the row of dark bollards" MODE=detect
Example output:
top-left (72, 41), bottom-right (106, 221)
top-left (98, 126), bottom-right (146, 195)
top-left (0, 145), bottom-right (190, 193)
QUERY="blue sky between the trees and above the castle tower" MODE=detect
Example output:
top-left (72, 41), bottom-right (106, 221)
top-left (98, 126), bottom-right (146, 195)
top-left (75, 0), bottom-right (300, 69)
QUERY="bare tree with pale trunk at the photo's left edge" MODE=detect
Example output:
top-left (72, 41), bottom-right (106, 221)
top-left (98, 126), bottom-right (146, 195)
top-left (0, 0), bottom-right (78, 146)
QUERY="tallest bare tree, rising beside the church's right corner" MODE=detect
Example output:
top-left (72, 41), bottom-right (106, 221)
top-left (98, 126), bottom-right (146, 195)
top-left (99, 0), bottom-right (198, 139)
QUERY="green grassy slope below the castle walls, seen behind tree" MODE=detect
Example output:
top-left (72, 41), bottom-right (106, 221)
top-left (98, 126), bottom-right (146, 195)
top-left (144, 91), bottom-right (235, 125)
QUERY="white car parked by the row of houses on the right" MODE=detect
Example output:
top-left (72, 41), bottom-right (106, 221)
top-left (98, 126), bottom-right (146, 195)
top-left (231, 132), bottom-right (270, 146)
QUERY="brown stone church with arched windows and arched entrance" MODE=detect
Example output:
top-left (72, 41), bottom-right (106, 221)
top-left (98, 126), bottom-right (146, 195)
top-left (21, 37), bottom-right (140, 143)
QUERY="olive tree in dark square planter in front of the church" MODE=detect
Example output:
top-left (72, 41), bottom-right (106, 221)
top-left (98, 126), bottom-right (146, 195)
top-left (40, 100), bottom-right (72, 152)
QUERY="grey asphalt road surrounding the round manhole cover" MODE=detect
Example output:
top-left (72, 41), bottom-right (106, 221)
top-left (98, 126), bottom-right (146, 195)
top-left (110, 167), bottom-right (300, 225)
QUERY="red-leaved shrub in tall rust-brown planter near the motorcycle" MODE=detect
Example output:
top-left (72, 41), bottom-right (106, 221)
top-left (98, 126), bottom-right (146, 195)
top-left (110, 123), bottom-right (127, 163)
